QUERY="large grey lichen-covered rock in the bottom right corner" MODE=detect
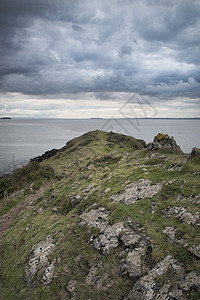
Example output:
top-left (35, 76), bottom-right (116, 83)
top-left (124, 256), bottom-right (200, 300)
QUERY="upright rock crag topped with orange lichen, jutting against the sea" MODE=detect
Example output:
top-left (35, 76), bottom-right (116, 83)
top-left (147, 133), bottom-right (182, 153)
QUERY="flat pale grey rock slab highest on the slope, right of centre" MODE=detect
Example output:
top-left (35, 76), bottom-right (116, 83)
top-left (111, 179), bottom-right (162, 205)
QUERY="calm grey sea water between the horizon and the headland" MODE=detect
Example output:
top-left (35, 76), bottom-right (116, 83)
top-left (0, 119), bottom-right (200, 175)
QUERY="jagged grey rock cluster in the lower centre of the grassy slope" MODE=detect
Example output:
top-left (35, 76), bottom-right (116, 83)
top-left (80, 208), bottom-right (152, 282)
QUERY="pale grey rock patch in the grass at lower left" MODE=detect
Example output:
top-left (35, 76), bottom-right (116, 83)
top-left (25, 236), bottom-right (55, 286)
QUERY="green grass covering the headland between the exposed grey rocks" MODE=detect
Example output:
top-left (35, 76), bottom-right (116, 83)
top-left (0, 131), bottom-right (200, 300)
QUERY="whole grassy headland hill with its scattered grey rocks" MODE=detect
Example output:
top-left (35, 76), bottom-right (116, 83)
top-left (0, 130), bottom-right (200, 300)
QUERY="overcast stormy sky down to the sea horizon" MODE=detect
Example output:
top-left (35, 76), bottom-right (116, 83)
top-left (0, 0), bottom-right (200, 118)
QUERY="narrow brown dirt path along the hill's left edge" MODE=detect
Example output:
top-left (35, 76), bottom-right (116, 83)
top-left (0, 184), bottom-right (50, 238)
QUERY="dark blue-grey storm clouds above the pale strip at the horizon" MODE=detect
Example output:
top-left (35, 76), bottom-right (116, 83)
top-left (0, 0), bottom-right (200, 98)
